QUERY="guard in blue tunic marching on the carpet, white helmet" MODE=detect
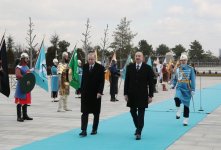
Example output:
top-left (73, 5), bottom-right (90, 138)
top-left (171, 54), bottom-right (195, 126)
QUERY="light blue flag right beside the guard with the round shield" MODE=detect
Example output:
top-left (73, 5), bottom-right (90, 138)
top-left (33, 41), bottom-right (48, 91)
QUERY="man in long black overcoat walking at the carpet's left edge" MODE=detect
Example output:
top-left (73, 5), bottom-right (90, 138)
top-left (79, 52), bottom-right (104, 137)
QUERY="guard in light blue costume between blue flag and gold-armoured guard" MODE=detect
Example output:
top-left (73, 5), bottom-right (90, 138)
top-left (51, 58), bottom-right (59, 102)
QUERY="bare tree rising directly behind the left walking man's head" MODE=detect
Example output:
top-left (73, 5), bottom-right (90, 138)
top-left (81, 18), bottom-right (91, 60)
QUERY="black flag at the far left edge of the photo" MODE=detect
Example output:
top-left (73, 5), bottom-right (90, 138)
top-left (0, 36), bottom-right (10, 97)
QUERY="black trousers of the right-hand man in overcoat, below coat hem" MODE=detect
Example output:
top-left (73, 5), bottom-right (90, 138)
top-left (130, 107), bottom-right (145, 134)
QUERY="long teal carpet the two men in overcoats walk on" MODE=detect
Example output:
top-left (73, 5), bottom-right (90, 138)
top-left (16, 85), bottom-right (221, 150)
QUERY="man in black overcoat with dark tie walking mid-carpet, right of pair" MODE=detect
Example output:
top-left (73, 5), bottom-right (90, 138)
top-left (124, 52), bottom-right (154, 140)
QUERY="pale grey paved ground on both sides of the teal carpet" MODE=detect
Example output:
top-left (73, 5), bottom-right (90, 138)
top-left (0, 77), bottom-right (221, 150)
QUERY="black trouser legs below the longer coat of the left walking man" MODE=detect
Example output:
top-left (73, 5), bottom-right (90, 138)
top-left (81, 113), bottom-right (100, 131)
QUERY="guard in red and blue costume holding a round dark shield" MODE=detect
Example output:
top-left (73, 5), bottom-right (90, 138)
top-left (15, 53), bottom-right (35, 122)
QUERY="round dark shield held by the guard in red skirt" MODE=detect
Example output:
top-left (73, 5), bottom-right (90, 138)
top-left (20, 73), bottom-right (35, 93)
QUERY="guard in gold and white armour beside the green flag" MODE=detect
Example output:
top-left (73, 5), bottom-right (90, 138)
top-left (58, 52), bottom-right (71, 112)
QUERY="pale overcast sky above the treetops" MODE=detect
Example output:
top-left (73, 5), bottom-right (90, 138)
top-left (0, 0), bottom-right (221, 56)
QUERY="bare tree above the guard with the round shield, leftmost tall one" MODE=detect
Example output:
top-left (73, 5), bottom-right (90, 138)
top-left (25, 17), bottom-right (38, 68)
